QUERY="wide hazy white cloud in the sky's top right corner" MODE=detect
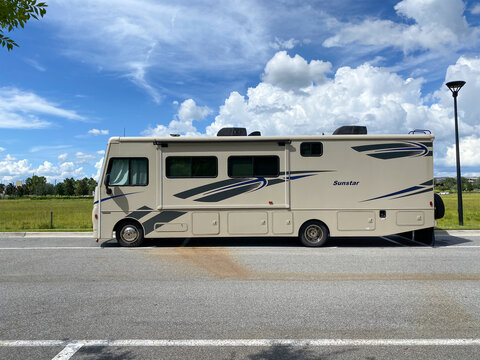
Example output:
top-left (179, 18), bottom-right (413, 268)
top-left (323, 0), bottom-right (479, 53)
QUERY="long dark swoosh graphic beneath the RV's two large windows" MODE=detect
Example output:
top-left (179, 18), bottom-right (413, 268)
top-left (174, 170), bottom-right (336, 202)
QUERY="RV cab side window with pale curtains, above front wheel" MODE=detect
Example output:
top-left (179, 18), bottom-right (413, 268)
top-left (108, 158), bottom-right (148, 186)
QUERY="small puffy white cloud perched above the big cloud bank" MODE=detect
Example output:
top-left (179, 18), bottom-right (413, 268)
top-left (263, 51), bottom-right (332, 90)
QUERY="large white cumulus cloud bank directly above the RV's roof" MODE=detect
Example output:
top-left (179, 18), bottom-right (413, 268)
top-left (207, 55), bottom-right (433, 135)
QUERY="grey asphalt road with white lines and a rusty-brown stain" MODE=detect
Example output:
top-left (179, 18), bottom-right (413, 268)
top-left (0, 233), bottom-right (480, 359)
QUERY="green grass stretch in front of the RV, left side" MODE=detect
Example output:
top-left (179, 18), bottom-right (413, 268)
top-left (0, 197), bottom-right (93, 231)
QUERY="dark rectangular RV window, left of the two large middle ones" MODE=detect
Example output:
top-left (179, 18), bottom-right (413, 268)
top-left (166, 156), bottom-right (218, 178)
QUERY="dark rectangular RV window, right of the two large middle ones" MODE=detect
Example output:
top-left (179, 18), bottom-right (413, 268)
top-left (228, 156), bottom-right (280, 177)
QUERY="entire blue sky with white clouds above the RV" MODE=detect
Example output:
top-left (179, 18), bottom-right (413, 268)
top-left (0, 0), bottom-right (480, 184)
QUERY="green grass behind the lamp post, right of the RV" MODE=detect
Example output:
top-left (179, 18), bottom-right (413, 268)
top-left (437, 192), bottom-right (480, 230)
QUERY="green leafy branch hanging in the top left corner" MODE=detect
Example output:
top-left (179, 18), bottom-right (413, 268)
top-left (0, 0), bottom-right (48, 51)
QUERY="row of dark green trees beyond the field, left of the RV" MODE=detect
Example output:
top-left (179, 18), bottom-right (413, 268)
top-left (0, 175), bottom-right (97, 197)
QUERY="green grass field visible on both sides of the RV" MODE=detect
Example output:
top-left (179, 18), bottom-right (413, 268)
top-left (0, 193), bottom-right (480, 231)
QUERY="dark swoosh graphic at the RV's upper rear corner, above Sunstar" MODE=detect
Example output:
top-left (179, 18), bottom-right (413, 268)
top-left (352, 141), bottom-right (433, 160)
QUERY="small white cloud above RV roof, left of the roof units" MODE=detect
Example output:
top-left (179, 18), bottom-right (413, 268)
top-left (142, 99), bottom-right (212, 137)
